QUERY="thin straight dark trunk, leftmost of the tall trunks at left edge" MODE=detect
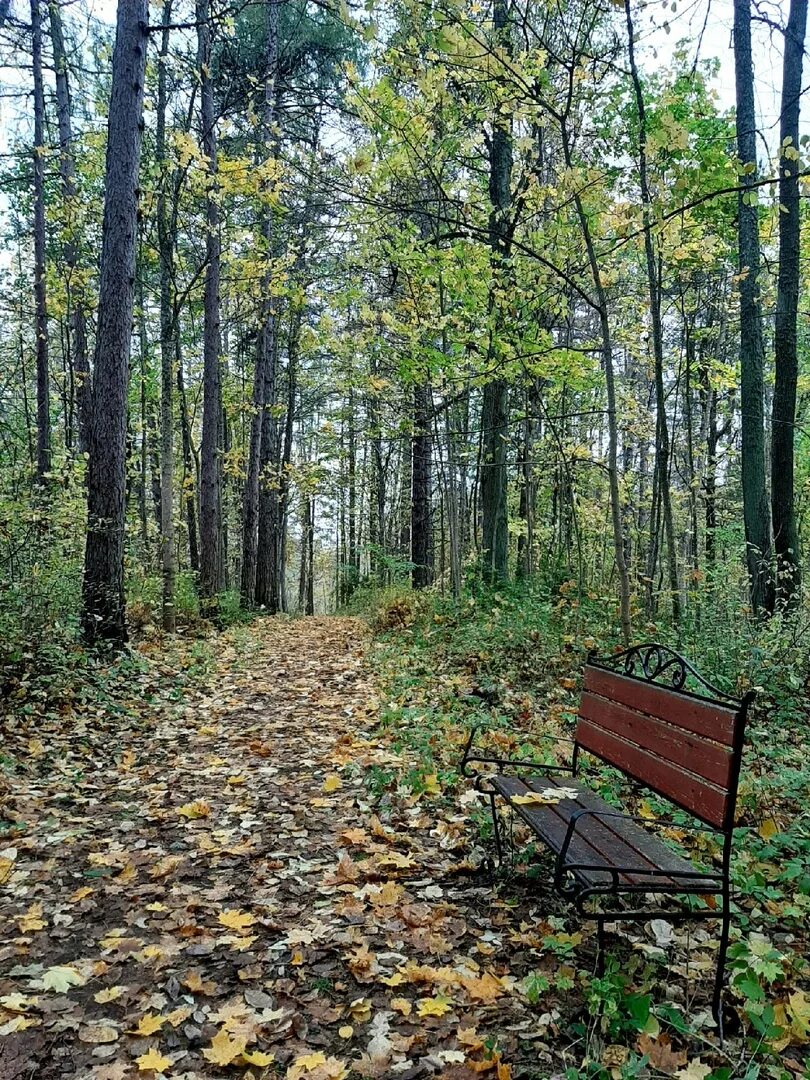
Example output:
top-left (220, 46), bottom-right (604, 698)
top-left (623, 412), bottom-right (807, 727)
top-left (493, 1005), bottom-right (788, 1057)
top-left (31, 0), bottom-right (51, 484)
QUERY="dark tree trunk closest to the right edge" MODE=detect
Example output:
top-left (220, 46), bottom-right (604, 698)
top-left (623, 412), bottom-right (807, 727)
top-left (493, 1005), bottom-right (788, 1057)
top-left (771, 0), bottom-right (808, 608)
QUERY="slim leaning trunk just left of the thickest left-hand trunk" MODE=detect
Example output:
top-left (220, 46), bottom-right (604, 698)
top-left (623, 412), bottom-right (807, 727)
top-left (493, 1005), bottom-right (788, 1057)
top-left (50, 0), bottom-right (92, 454)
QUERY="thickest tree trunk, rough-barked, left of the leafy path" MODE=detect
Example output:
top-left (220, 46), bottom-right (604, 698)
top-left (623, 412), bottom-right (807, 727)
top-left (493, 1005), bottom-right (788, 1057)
top-left (82, 0), bottom-right (148, 646)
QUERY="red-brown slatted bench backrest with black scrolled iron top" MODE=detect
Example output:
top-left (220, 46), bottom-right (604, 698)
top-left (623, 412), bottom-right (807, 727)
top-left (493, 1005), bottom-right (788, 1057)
top-left (575, 645), bottom-right (753, 832)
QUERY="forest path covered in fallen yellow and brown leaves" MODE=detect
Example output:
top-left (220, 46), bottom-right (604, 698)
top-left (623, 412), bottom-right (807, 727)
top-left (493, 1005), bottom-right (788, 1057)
top-left (0, 619), bottom-right (807, 1080)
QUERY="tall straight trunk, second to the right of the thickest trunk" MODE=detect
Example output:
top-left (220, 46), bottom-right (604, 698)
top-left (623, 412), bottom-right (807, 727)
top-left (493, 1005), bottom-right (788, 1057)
top-left (197, 0), bottom-right (222, 616)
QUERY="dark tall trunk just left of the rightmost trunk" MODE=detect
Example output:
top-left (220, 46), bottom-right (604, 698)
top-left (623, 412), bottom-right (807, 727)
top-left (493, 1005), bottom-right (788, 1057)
top-left (734, 0), bottom-right (773, 612)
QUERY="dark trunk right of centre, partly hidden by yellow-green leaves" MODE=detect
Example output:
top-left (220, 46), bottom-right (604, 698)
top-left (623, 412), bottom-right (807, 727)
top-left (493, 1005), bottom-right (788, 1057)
top-left (480, 0), bottom-right (512, 582)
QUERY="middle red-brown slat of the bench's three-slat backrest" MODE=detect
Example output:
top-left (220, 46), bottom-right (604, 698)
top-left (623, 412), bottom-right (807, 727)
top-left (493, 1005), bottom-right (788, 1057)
top-left (579, 690), bottom-right (731, 788)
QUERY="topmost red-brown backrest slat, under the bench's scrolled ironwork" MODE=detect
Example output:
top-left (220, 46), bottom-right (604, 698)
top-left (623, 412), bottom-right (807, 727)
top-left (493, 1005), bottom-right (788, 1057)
top-left (584, 664), bottom-right (738, 746)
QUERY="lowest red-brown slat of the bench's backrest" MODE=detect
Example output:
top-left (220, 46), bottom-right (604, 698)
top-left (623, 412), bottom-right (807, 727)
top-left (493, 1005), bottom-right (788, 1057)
top-left (577, 717), bottom-right (727, 828)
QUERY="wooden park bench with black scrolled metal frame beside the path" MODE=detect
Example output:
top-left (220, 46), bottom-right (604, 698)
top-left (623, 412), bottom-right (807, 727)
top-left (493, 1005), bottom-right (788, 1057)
top-left (461, 644), bottom-right (754, 1038)
